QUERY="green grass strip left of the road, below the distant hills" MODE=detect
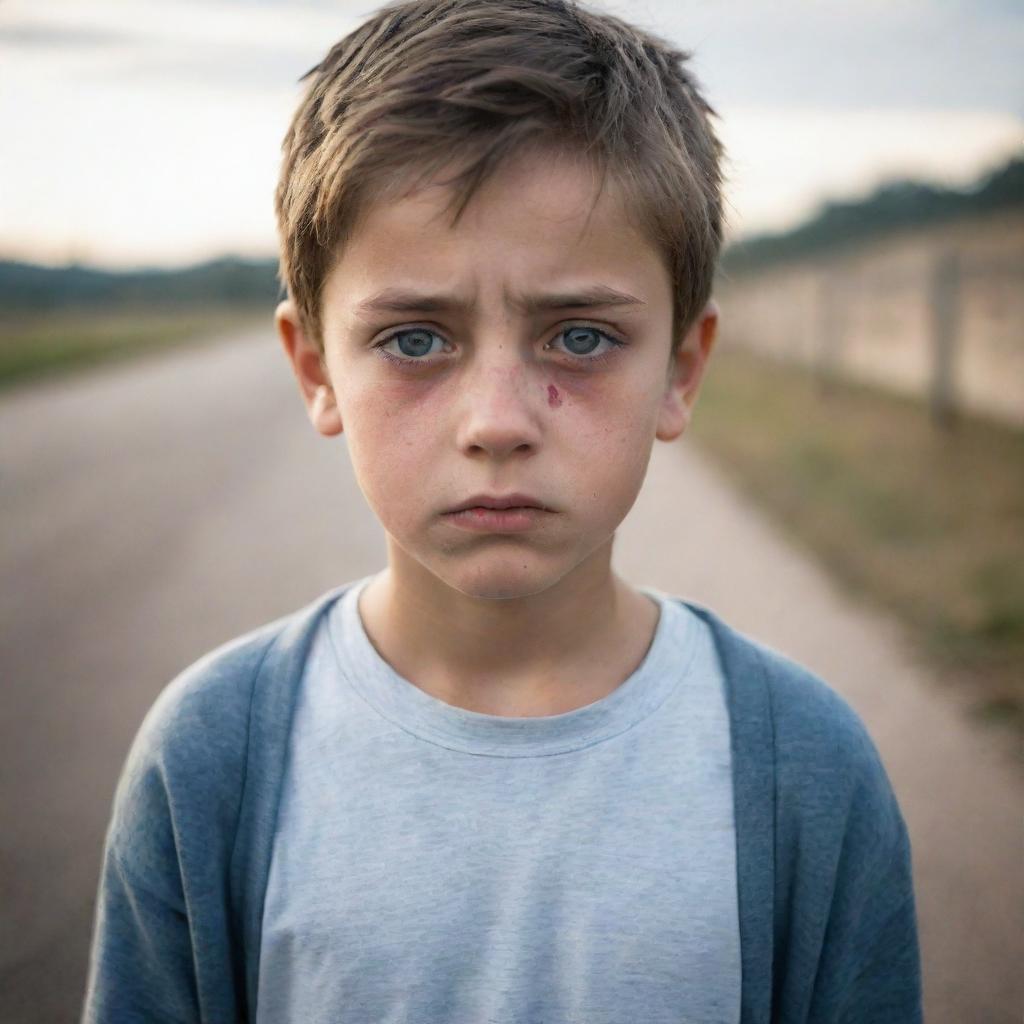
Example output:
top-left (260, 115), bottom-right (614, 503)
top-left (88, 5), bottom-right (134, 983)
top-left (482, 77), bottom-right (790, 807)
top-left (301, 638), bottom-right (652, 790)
top-left (0, 305), bottom-right (273, 388)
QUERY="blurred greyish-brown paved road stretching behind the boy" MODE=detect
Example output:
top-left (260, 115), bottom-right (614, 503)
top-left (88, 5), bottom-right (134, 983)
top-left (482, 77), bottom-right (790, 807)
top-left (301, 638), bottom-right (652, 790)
top-left (0, 334), bottom-right (1024, 1024)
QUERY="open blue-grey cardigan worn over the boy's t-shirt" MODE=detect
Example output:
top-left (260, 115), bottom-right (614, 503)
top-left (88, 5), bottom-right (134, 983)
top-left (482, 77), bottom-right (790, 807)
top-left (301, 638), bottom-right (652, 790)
top-left (83, 587), bottom-right (922, 1024)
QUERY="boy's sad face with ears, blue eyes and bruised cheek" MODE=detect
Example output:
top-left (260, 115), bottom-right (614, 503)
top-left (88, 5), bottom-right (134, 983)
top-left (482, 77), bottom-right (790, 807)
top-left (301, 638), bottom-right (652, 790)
top-left (278, 148), bottom-right (716, 599)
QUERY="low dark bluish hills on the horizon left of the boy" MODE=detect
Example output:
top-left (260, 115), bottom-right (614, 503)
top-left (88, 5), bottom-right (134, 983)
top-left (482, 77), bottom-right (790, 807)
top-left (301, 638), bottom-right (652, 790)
top-left (0, 257), bottom-right (278, 312)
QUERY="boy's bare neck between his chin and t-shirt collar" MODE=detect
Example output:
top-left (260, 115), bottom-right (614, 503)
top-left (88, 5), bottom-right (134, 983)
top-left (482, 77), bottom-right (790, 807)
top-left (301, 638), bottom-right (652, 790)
top-left (359, 541), bottom-right (658, 718)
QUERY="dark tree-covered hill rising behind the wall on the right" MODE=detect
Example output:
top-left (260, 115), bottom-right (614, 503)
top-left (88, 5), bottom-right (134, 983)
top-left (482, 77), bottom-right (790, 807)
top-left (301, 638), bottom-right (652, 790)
top-left (722, 158), bottom-right (1024, 276)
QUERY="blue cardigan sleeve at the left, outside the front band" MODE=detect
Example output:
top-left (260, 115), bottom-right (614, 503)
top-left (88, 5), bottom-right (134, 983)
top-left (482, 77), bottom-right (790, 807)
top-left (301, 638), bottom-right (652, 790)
top-left (82, 634), bottom-right (268, 1024)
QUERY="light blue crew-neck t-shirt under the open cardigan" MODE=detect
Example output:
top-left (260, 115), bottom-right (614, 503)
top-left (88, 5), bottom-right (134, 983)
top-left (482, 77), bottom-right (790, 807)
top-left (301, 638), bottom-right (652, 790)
top-left (257, 577), bottom-right (740, 1024)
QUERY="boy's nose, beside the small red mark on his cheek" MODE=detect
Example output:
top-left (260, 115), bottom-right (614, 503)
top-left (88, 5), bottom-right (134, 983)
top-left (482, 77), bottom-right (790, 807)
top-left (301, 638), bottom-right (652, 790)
top-left (457, 358), bottom-right (544, 458)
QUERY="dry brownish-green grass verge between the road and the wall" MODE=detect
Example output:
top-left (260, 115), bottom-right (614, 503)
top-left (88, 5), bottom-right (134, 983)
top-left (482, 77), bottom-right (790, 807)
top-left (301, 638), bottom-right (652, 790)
top-left (692, 346), bottom-right (1024, 732)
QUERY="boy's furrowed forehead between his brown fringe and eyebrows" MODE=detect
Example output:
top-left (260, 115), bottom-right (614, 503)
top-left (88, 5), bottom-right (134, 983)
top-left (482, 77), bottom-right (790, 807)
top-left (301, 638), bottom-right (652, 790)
top-left (325, 154), bottom-right (671, 307)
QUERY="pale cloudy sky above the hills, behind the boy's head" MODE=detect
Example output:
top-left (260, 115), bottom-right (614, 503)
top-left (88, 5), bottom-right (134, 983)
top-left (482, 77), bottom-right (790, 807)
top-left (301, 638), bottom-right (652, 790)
top-left (0, 0), bottom-right (1024, 267)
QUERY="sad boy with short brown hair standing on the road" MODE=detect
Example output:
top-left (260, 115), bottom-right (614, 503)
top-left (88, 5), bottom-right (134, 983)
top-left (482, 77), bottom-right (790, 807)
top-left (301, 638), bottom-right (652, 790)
top-left (85, 0), bottom-right (921, 1024)
